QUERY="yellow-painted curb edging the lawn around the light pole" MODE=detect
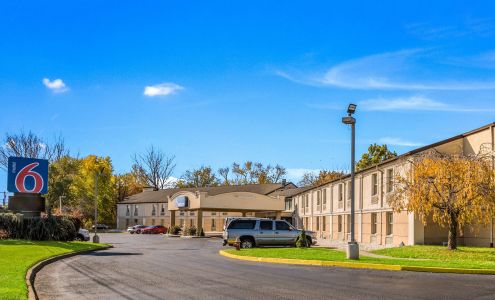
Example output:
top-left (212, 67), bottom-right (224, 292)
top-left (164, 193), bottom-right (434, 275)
top-left (219, 250), bottom-right (495, 275)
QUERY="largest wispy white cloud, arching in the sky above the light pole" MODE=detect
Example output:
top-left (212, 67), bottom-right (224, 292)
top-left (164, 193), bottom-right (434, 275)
top-left (275, 49), bottom-right (495, 90)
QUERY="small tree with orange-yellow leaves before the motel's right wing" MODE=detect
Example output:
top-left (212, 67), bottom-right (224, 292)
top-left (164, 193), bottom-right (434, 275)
top-left (388, 152), bottom-right (495, 250)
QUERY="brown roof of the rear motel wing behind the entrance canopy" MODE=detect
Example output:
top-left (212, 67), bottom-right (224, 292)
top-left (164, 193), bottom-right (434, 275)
top-left (119, 182), bottom-right (293, 204)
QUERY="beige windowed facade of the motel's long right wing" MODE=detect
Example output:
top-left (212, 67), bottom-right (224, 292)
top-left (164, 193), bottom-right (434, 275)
top-left (292, 123), bottom-right (495, 247)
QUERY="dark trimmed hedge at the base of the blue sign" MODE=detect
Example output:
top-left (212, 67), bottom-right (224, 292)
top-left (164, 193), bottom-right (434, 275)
top-left (0, 213), bottom-right (81, 241)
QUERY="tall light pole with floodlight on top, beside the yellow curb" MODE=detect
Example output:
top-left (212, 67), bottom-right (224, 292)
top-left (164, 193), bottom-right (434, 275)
top-left (342, 103), bottom-right (359, 259)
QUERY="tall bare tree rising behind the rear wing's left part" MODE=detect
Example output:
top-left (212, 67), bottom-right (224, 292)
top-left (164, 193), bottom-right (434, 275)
top-left (133, 145), bottom-right (175, 189)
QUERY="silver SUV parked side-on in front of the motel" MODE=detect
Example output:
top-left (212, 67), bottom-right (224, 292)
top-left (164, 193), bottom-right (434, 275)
top-left (223, 218), bottom-right (316, 248)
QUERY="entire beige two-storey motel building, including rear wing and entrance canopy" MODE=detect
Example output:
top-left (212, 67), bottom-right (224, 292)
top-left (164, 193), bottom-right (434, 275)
top-left (117, 123), bottom-right (495, 248)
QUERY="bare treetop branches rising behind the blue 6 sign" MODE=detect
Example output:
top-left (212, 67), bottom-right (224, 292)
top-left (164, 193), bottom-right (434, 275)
top-left (0, 131), bottom-right (69, 169)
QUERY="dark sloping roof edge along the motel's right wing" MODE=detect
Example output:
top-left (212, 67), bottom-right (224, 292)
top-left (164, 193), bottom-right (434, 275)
top-left (292, 122), bottom-right (495, 196)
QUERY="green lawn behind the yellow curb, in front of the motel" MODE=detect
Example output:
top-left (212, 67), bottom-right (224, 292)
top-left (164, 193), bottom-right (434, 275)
top-left (227, 246), bottom-right (495, 269)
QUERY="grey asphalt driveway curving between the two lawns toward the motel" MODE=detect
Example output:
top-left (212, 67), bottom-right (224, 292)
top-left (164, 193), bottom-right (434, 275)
top-left (35, 234), bottom-right (495, 300)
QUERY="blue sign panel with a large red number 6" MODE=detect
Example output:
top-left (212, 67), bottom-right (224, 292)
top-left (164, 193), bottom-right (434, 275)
top-left (7, 157), bottom-right (48, 194)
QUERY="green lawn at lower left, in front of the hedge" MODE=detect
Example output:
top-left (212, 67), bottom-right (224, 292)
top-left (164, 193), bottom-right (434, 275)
top-left (0, 240), bottom-right (105, 299)
